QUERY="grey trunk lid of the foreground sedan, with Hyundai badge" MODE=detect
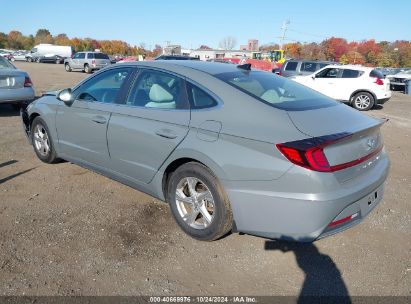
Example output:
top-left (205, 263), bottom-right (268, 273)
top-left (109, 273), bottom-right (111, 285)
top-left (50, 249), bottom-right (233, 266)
top-left (288, 104), bottom-right (385, 182)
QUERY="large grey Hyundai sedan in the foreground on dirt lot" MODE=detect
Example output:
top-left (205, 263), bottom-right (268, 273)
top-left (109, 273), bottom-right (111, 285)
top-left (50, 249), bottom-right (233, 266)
top-left (22, 60), bottom-right (389, 241)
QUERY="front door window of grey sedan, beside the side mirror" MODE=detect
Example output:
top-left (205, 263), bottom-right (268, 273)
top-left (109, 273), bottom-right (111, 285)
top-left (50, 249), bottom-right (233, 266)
top-left (74, 67), bottom-right (132, 103)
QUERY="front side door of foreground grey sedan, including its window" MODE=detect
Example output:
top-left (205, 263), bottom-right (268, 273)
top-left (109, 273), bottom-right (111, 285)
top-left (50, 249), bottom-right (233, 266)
top-left (56, 67), bottom-right (132, 167)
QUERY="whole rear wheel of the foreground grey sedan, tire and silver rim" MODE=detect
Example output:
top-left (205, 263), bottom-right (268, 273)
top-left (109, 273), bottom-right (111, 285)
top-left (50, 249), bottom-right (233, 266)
top-left (166, 162), bottom-right (233, 241)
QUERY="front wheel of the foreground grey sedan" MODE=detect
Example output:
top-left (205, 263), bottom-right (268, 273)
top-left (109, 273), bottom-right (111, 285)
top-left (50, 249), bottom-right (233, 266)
top-left (31, 116), bottom-right (58, 164)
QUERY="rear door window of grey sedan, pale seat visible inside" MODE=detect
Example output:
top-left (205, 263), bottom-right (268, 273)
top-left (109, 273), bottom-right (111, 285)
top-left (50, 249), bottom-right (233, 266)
top-left (126, 69), bottom-right (188, 109)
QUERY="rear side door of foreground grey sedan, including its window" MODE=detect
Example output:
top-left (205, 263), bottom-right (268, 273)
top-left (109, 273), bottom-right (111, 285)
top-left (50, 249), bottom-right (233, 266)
top-left (107, 69), bottom-right (190, 183)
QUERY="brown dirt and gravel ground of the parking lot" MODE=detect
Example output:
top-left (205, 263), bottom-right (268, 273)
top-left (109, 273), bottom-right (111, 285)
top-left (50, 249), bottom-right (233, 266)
top-left (0, 63), bottom-right (411, 296)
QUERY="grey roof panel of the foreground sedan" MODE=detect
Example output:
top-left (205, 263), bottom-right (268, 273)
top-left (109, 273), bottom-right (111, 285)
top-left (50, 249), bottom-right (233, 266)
top-left (121, 60), bottom-right (245, 75)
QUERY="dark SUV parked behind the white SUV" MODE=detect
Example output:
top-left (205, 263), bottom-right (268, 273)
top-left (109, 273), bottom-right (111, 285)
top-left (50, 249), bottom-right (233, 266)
top-left (279, 59), bottom-right (335, 77)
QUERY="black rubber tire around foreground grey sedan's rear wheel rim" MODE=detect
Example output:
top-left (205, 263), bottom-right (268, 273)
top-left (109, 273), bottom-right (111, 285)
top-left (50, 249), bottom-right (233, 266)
top-left (166, 162), bottom-right (233, 241)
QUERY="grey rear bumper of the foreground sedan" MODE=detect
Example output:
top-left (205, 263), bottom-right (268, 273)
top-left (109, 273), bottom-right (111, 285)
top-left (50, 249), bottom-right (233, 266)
top-left (223, 153), bottom-right (389, 242)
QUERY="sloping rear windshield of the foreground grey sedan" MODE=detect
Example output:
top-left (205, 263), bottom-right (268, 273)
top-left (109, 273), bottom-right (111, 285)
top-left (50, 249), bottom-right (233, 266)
top-left (215, 71), bottom-right (338, 111)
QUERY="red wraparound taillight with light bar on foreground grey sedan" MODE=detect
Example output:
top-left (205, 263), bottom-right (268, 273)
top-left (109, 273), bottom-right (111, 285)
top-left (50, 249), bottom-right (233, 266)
top-left (276, 132), bottom-right (383, 172)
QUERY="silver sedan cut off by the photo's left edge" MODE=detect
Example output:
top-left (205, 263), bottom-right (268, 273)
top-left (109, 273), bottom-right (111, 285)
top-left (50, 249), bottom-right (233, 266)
top-left (0, 57), bottom-right (34, 107)
